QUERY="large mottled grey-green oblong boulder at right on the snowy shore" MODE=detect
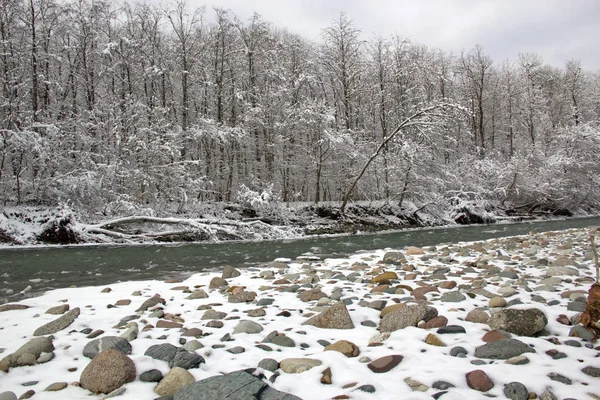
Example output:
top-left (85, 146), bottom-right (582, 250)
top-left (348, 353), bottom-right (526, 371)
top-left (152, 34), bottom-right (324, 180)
top-left (488, 308), bottom-right (548, 336)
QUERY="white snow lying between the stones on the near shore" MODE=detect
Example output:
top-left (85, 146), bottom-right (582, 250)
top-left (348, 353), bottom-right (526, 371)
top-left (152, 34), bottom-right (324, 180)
top-left (0, 230), bottom-right (600, 400)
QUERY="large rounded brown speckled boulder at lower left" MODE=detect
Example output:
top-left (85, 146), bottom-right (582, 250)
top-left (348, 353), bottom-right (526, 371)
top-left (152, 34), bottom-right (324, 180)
top-left (79, 350), bottom-right (136, 394)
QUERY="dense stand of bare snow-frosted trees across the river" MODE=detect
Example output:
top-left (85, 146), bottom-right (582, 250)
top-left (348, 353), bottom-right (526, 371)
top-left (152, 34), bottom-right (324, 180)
top-left (0, 0), bottom-right (600, 219)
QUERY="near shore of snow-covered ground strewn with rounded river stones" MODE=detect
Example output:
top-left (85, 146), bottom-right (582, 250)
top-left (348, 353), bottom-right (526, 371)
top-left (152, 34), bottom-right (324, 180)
top-left (0, 229), bottom-right (600, 400)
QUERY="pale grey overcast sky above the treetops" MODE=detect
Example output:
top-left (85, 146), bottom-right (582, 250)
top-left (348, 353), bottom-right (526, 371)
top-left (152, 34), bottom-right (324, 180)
top-left (188, 0), bottom-right (600, 71)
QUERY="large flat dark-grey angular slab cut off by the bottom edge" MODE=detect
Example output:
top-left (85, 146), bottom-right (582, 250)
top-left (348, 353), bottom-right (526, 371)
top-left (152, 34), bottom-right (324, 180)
top-left (173, 370), bottom-right (301, 400)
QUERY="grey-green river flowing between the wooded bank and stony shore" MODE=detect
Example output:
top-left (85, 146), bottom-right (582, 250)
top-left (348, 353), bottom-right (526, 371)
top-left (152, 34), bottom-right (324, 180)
top-left (0, 217), bottom-right (600, 304)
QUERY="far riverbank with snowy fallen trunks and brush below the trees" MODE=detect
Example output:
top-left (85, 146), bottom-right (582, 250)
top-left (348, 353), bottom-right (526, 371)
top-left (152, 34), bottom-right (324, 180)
top-left (0, 202), bottom-right (600, 249)
